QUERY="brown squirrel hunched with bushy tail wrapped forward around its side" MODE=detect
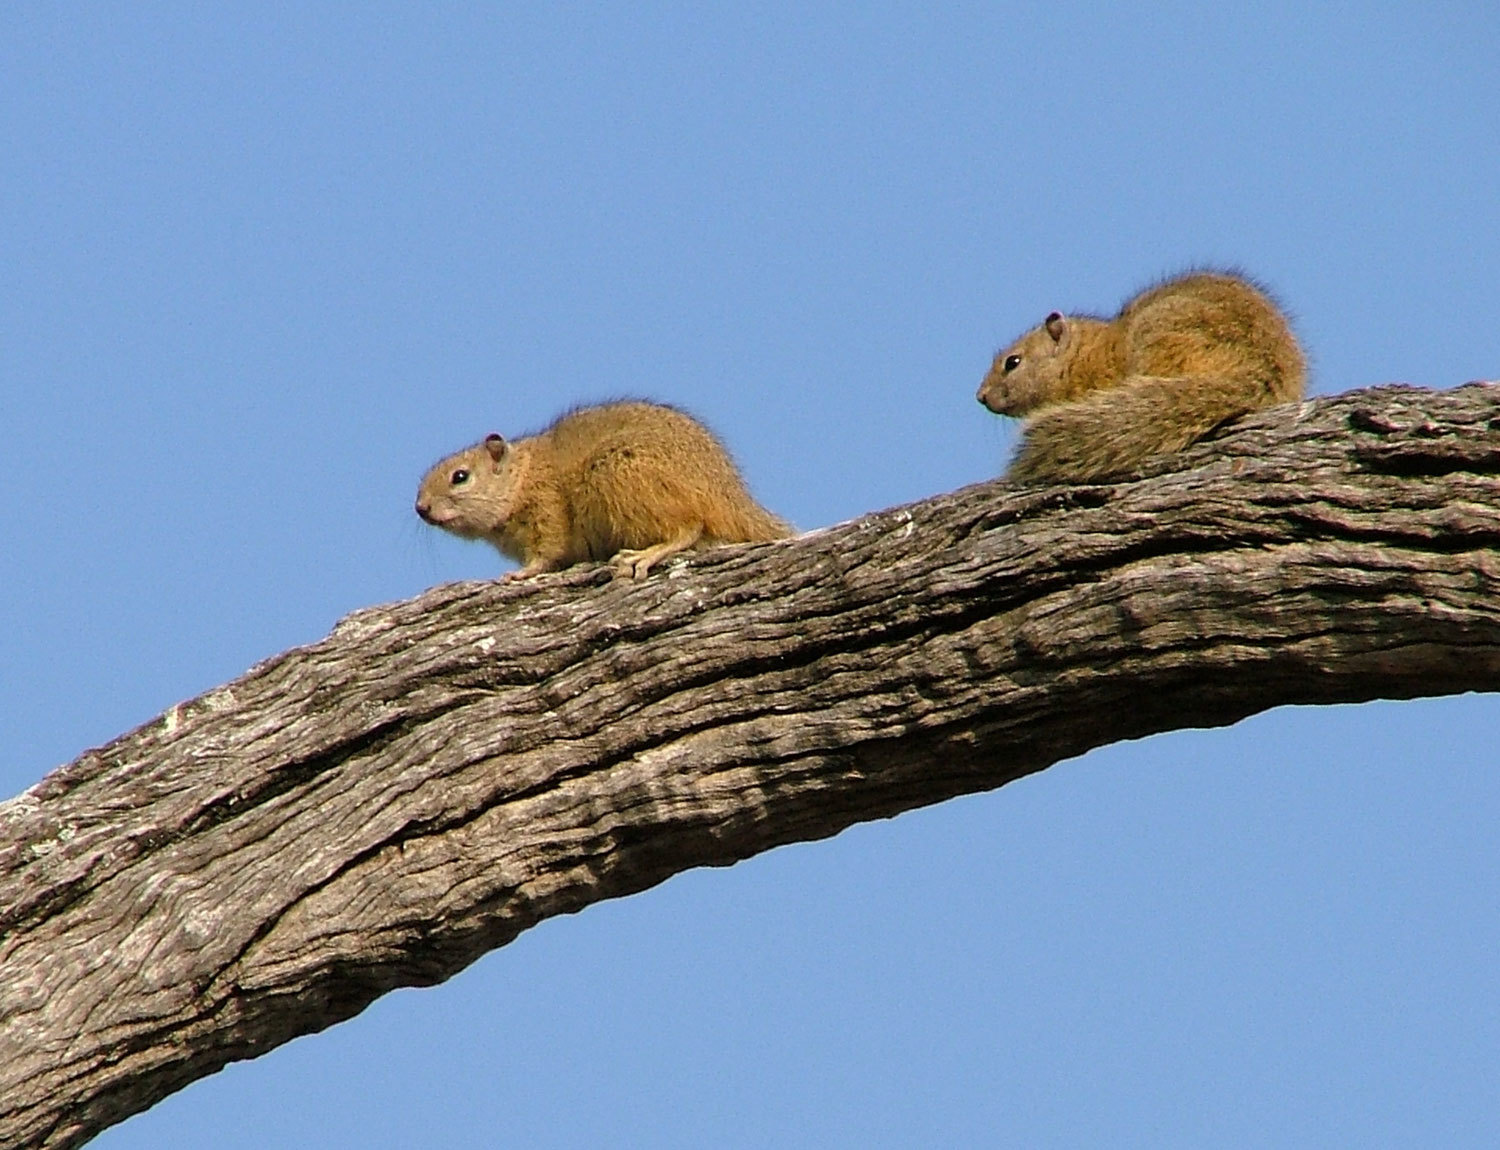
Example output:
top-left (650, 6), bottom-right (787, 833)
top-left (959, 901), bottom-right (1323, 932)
top-left (980, 271), bottom-right (1307, 483)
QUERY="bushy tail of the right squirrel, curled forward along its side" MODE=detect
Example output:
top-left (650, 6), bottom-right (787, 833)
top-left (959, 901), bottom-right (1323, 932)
top-left (1007, 375), bottom-right (1275, 483)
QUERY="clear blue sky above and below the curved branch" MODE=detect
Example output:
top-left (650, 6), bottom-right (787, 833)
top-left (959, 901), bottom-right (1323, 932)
top-left (0, 3), bottom-right (1500, 1150)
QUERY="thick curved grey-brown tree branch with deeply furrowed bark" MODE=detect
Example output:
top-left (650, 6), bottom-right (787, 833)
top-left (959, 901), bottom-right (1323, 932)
top-left (0, 385), bottom-right (1500, 1147)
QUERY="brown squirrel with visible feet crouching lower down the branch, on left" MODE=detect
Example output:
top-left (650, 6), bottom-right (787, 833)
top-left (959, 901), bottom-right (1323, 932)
top-left (417, 400), bottom-right (792, 579)
